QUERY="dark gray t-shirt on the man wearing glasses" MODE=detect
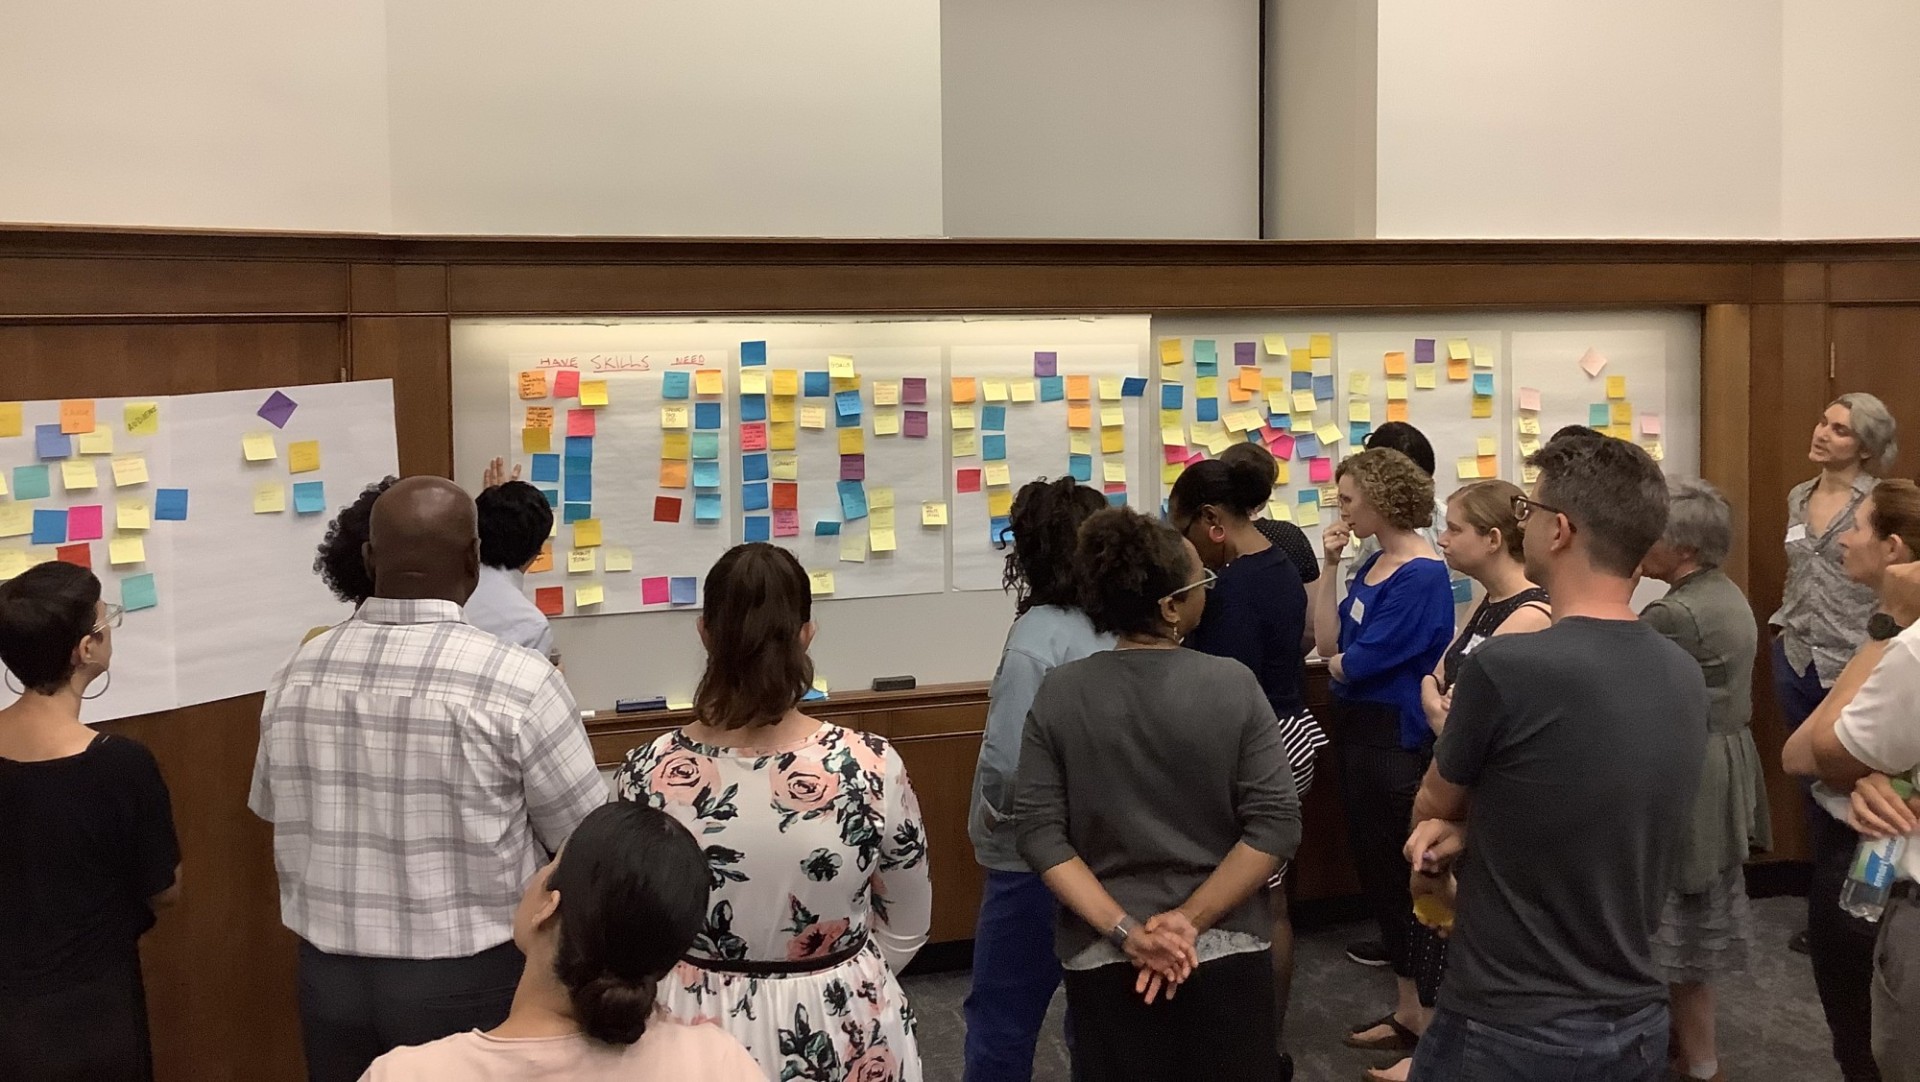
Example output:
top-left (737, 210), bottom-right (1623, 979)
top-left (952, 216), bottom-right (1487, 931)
top-left (1434, 616), bottom-right (1707, 1024)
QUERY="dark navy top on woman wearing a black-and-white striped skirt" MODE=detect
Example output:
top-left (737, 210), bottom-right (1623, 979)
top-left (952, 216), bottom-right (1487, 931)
top-left (1187, 545), bottom-right (1308, 717)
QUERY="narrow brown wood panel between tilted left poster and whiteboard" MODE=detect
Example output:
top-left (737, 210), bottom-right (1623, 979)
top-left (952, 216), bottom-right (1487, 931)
top-left (348, 317), bottom-right (453, 482)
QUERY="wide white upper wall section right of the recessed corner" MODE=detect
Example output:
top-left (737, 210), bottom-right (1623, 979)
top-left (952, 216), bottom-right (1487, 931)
top-left (1377, 0), bottom-right (1774, 238)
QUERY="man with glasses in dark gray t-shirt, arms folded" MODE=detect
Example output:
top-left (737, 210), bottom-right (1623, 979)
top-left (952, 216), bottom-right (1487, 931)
top-left (1407, 439), bottom-right (1707, 1082)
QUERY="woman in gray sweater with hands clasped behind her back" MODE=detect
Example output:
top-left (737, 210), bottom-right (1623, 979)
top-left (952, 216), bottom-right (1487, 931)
top-left (1014, 508), bottom-right (1300, 1082)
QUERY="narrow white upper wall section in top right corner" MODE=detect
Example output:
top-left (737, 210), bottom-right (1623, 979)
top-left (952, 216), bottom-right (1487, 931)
top-left (1780, 0), bottom-right (1920, 238)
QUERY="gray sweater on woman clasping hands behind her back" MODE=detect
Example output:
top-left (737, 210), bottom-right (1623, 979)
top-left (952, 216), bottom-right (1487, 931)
top-left (1014, 650), bottom-right (1300, 959)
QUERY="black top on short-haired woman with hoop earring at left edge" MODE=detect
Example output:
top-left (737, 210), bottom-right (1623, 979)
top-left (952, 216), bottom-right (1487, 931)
top-left (0, 733), bottom-right (180, 994)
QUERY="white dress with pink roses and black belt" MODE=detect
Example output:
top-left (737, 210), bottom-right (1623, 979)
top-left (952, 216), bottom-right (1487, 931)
top-left (614, 725), bottom-right (933, 1082)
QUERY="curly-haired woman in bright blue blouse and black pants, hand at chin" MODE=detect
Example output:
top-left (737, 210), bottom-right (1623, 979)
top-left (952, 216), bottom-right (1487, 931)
top-left (1313, 447), bottom-right (1453, 1051)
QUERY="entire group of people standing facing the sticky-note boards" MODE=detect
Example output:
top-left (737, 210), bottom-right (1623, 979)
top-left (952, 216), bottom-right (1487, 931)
top-left (0, 395), bottom-right (1920, 1082)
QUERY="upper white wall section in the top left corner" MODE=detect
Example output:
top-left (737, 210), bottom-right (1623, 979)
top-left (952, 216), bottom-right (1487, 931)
top-left (0, 0), bottom-right (392, 230)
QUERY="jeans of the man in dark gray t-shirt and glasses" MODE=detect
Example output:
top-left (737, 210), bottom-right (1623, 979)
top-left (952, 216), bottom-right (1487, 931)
top-left (1407, 1003), bottom-right (1667, 1082)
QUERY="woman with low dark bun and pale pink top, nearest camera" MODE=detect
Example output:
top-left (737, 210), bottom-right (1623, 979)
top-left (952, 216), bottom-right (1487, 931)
top-left (361, 804), bottom-right (764, 1082)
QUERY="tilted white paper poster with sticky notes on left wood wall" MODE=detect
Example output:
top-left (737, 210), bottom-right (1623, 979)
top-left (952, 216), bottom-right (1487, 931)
top-left (0, 380), bottom-right (397, 721)
